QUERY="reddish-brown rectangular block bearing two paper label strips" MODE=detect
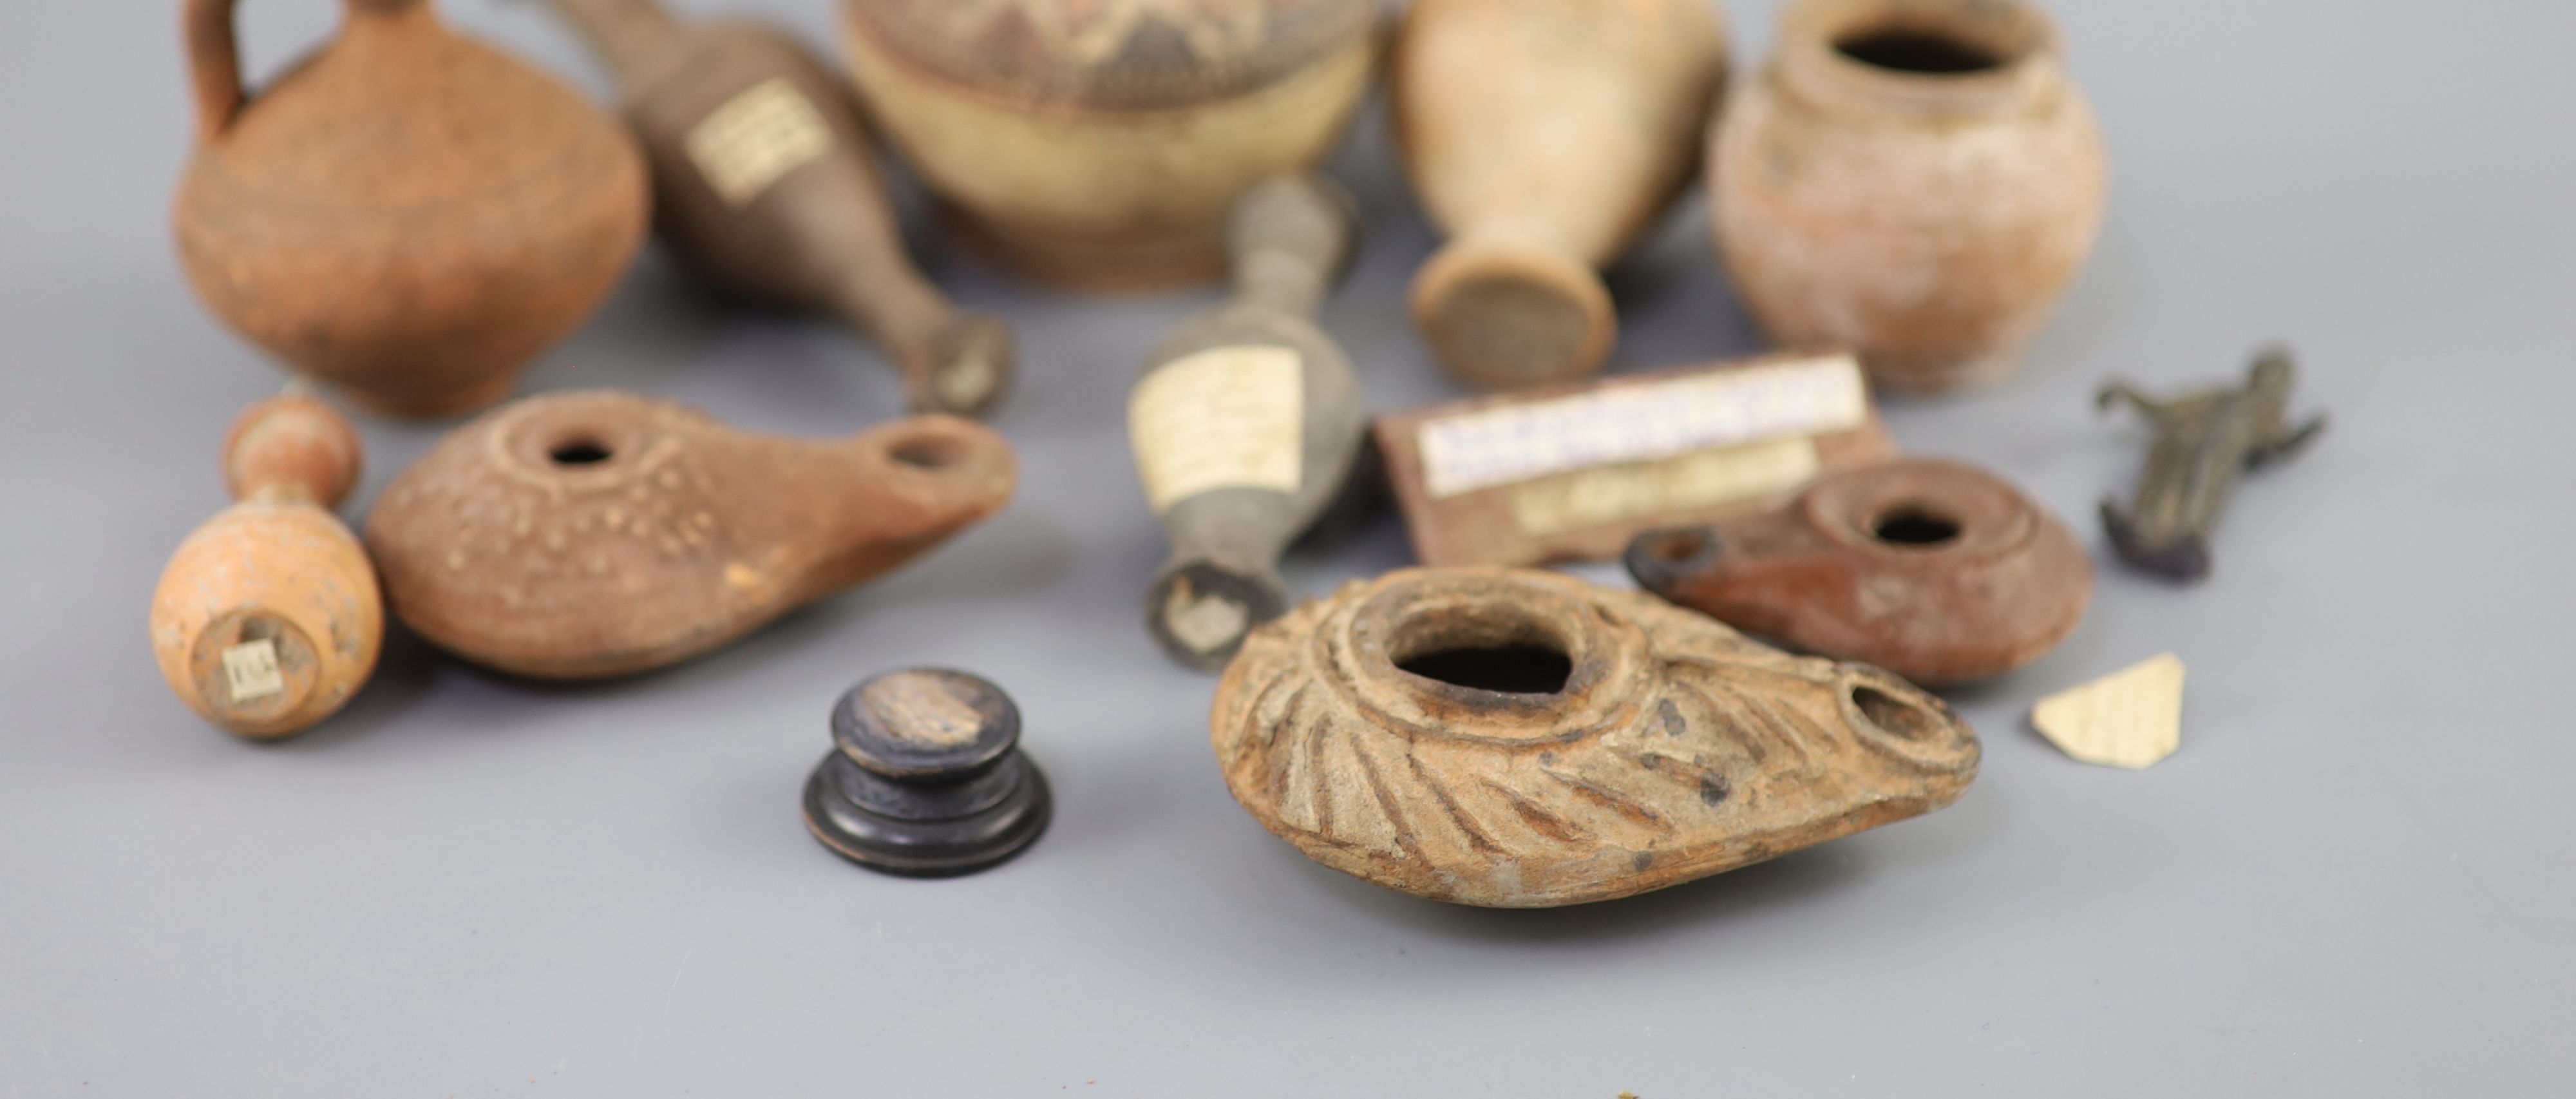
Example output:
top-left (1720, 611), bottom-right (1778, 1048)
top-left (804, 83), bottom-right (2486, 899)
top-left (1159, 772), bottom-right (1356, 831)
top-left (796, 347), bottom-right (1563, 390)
top-left (1376, 354), bottom-right (1896, 565)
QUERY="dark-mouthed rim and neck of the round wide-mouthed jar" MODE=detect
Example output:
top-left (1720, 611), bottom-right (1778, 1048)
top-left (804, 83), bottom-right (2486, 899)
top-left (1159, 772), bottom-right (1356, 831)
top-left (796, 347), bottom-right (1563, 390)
top-left (1772, 0), bottom-right (2063, 119)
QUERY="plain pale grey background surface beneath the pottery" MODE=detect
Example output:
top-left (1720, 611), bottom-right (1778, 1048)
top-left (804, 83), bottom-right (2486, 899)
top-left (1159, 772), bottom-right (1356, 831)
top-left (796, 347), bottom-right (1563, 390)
top-left (0, 0), bottom-right (2576, 1099)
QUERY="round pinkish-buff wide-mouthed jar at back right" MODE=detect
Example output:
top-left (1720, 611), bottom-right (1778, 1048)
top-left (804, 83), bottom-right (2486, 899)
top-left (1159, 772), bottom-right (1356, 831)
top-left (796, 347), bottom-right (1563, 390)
top-left (1710, 0), bottom-right (2107, 392)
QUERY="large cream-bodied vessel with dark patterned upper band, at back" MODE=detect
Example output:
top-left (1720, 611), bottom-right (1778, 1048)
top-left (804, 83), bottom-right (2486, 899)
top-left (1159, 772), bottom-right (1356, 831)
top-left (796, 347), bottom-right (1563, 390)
top-left (842, 0), bottom-right (1378, 289)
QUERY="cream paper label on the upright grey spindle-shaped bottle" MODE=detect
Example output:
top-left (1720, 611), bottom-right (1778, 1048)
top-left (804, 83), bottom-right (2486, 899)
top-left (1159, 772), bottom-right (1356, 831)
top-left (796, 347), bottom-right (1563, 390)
top-left (1128, 346), bottom-right (1306, 513)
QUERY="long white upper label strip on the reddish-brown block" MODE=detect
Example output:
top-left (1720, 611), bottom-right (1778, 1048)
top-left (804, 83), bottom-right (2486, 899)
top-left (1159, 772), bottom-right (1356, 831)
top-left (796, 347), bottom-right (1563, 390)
top-left (1414, 356), bottom-right (1870, 501)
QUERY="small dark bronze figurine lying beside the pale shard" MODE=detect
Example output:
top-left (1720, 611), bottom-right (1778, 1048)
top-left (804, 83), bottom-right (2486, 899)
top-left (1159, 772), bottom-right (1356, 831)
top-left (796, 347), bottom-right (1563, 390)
top-left (2094, 349), bottom-right (2326, 580)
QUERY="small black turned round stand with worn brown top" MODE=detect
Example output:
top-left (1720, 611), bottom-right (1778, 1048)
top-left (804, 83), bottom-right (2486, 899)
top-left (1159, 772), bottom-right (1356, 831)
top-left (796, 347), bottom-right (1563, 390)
top-left (804, 668), bottom-right (1054, 877)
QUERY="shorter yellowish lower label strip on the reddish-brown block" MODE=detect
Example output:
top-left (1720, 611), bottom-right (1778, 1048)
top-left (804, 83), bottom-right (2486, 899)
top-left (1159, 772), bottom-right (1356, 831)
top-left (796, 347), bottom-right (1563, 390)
top-left (1510, 436), bottom-right (1821, 537)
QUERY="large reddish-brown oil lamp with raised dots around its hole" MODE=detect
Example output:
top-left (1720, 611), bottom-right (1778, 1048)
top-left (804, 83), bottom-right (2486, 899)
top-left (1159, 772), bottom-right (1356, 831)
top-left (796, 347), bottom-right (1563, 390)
top-left (366, 390), bottom-right (1018, 678)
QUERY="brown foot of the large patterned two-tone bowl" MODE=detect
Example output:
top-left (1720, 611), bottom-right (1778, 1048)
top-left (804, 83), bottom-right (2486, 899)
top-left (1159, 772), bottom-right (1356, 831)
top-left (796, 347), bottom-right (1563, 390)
top-left (940, 204), bottom-right (1226, 294)
